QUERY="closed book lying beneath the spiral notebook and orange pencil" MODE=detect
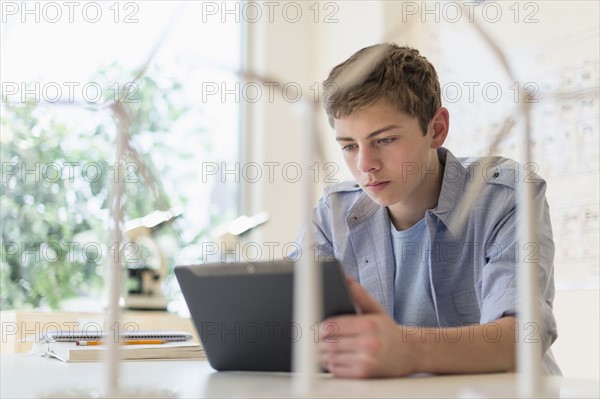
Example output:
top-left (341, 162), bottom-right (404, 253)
top-left (31, 341), bottom-right (205, 363)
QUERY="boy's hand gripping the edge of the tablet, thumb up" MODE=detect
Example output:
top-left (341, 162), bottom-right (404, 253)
top-left (319, 280), bottom-right (415, 378)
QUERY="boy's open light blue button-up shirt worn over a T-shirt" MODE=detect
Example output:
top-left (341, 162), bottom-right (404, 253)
top-left (298, 148), bottom-right (560, 374)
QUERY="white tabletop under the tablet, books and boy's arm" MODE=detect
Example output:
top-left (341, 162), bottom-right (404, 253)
top-left (0, 354), bottom-right (600, 398)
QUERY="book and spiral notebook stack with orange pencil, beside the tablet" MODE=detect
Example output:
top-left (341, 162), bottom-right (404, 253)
top-left (31, 331), bottom-right (205, 362)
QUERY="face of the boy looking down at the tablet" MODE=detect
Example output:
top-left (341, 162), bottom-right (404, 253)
top-left (334, 102), bottom-right (447, 210)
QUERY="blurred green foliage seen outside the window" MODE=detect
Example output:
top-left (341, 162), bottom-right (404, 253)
top-left (0, 65), bottom-right (209, 309)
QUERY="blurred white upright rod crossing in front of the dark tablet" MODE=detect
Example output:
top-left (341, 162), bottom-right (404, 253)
top-left (292, 104), bottom-right (322, 397)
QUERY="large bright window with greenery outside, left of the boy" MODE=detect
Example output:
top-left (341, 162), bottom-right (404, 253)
top-left (0, 1), bottom-right (242, 309)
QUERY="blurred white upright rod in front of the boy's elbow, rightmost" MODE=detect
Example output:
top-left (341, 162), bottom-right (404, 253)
top-left (516, 105), bottom-right (544, 398)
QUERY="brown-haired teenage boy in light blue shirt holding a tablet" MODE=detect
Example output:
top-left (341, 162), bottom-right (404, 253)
top-left (304, 44), bottom-right (560, 377)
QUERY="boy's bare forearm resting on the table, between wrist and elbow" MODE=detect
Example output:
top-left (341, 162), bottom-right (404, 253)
top-left (410, 317), bottom-right (517, 374)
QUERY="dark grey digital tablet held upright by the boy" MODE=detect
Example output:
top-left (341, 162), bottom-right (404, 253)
top-left (175, 260), bottom-right (356, 371)
